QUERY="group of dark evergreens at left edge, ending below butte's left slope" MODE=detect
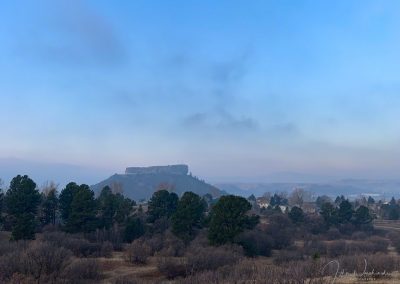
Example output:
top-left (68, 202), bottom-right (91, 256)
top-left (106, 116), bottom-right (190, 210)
top-left (0, 175), bottom-right (135, 240)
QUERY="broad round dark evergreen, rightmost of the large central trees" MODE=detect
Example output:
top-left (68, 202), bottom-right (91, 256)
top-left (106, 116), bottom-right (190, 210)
top-left (208, 195), bottom-right (259, 245)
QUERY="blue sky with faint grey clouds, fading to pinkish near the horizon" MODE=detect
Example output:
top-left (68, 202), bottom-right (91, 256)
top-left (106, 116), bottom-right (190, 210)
top-left (0, 0), bottom-right (400, 183)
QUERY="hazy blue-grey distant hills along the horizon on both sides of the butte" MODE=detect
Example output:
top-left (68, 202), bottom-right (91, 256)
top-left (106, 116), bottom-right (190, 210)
top-left (0, 158), bottom-right (400, 199)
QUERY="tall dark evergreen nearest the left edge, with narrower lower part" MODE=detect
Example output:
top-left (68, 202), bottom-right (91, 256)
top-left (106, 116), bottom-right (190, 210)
top-left (5, 175), bottom-right (40, 240)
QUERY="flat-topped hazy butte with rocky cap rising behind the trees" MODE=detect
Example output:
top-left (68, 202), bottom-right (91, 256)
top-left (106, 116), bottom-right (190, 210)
top-left (92, 165), bottom-right (222, 201)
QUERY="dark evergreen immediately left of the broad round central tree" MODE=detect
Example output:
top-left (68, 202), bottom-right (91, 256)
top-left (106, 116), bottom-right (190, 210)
top-left (172, 192), bottom-right (207, 241)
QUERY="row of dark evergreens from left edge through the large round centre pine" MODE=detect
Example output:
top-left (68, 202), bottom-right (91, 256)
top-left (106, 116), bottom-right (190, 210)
top-left (0, 175), bottom-right (259, 248)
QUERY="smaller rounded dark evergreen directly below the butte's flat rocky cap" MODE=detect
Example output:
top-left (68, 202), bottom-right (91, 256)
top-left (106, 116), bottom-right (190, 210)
top-left (147, 189), bottom-right (179, 223)
